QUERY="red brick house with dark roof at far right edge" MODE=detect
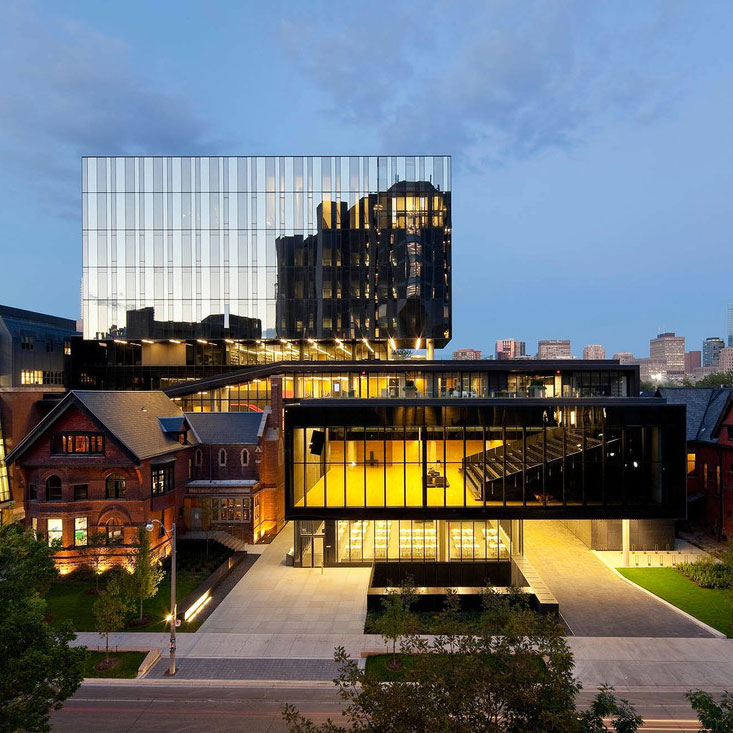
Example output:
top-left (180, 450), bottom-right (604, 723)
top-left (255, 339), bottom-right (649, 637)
top-left (657, 387), bottom-right (733, 539)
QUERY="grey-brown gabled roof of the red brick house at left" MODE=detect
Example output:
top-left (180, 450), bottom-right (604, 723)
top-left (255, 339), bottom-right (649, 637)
top-left (6, 390), bottom-right (183, 463)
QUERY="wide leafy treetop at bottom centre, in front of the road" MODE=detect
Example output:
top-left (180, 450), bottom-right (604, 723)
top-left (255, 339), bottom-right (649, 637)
top-left (283, 593), bottom-right (642, 733)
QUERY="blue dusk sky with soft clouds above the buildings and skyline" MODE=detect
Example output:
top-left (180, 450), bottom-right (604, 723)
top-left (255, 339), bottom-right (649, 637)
top-left (0, 0), bottom-right (733, 357)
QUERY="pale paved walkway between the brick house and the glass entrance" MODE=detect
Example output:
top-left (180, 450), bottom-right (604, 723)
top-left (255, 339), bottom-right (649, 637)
top-left (198, 524), bottom-right (371, 636)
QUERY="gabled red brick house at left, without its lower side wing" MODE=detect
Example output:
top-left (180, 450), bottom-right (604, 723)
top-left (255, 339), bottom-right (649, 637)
top-left (6, 391), bottom-right (191, 573)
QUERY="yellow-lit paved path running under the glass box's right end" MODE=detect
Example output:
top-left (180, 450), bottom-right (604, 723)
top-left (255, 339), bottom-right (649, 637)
top-left (524, 520), bottom-right (711, 637)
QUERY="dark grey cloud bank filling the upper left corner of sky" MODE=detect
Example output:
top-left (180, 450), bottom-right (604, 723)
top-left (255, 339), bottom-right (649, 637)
top-left (0, 3), bottom-right (221, 217)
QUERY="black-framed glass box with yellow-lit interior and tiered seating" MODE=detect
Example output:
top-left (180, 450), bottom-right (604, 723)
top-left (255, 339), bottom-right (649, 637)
top-left (285, 400), bottom-right (685, 519)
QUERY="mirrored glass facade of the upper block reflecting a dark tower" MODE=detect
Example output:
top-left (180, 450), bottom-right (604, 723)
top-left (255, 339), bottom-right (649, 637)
top-left (82, 156), bottom-right (451, 346)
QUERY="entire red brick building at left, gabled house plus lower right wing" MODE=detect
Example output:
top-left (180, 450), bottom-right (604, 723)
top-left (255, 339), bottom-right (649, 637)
top-left (6, 384), bottom-right (283, 573)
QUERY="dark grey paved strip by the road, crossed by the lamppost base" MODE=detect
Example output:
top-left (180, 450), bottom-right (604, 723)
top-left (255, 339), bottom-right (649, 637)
top-left (147, 657), bottom-right (338, 682)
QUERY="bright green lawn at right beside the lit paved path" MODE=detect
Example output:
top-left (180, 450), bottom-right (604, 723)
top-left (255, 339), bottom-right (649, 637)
top-left (618, 568), bottom-right (733, 637)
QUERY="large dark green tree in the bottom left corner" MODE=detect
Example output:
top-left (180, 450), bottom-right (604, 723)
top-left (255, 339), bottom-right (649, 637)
top-left (0, 524), bottom-right (85, 731)
